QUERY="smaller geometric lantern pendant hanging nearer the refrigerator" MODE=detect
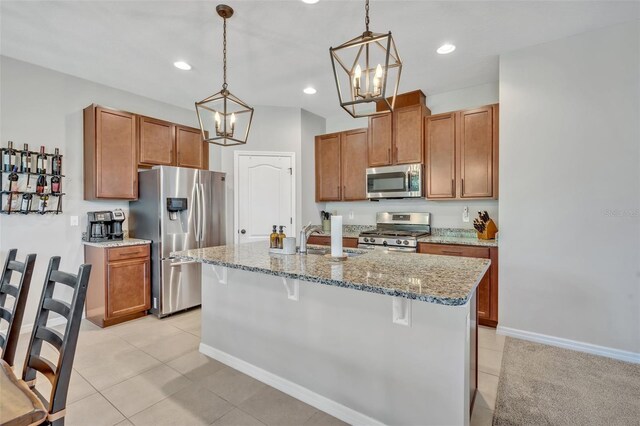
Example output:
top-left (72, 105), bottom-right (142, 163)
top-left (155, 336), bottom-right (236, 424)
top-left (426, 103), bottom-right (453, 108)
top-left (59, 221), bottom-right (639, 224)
top-left (196, 4), bottom-right (253, 146)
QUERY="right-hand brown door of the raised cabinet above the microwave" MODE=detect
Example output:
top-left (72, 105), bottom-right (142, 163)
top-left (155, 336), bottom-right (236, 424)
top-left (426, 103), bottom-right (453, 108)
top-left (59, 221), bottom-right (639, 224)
top-left (393, 105), bottom-right (423, 164)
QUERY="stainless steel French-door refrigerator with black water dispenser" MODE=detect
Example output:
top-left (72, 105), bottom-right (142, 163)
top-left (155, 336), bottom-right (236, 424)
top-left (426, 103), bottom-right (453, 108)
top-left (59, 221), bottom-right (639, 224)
top-left (129, 166), bottom-right (225, 317)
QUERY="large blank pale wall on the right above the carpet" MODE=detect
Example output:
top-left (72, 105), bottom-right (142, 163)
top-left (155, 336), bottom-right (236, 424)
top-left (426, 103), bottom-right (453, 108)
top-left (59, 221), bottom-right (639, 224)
top-left (500, 21), bottom-right (640, 360)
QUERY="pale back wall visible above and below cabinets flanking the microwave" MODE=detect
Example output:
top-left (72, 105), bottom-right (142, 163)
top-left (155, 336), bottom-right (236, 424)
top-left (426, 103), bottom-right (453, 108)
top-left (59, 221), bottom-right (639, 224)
top-left (322, 83), bottom-right (498, 229)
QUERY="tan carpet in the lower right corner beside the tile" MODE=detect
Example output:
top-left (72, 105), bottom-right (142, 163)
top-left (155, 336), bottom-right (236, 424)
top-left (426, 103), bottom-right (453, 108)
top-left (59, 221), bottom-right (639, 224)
top-left (493, 337), bottom-right (640, 426)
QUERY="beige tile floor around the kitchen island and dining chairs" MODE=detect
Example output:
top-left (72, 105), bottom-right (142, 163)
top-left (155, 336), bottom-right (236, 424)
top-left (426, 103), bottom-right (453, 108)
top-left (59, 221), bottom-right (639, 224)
top-left (8, 309), bottom-right (504, 426)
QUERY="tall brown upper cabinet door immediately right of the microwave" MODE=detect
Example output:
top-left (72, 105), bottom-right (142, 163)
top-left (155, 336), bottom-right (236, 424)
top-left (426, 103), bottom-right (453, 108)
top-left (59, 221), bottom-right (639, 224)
top-left (425, 113), bottom-right (456, 198)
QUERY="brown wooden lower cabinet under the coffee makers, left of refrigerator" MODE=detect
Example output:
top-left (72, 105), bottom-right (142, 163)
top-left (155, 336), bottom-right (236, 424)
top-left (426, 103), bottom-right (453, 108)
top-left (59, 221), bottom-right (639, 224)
top-left (85, 244), bottom-right (151, 327)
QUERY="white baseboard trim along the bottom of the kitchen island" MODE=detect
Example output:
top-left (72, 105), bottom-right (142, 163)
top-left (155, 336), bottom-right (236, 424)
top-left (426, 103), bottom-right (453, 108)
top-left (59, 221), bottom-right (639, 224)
top-left (200, 343), bottom-right (383, 426)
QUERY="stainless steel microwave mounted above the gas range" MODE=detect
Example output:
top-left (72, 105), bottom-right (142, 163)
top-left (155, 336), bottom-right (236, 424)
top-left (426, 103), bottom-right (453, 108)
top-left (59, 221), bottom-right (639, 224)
top-left (367, 163), bottom-right (423, 200)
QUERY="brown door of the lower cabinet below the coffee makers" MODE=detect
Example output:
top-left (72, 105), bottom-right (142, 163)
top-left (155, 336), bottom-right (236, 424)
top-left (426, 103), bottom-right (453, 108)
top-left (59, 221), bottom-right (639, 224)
top-left (107, 257), bottom-right (151, 318)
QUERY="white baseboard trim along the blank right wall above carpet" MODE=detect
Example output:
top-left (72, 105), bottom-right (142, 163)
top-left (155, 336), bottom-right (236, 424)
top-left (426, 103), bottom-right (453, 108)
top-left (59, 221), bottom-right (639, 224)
top-left (496, 325), bottom-right (640, 364)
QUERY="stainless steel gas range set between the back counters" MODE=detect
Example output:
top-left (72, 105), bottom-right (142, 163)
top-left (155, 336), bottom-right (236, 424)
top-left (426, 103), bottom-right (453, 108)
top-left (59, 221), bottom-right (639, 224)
top-left (358, 212), bottom-right (431, 253)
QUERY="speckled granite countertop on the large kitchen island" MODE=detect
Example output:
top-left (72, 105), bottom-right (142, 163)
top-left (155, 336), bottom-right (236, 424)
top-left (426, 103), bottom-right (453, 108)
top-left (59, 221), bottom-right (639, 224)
top-left (171, 241), bottom-right (491, 306)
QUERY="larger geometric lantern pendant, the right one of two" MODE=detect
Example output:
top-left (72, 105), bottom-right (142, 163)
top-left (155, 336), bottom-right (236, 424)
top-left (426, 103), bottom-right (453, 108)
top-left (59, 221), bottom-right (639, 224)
top-left (329, 0), bottom-right (402, 118)
